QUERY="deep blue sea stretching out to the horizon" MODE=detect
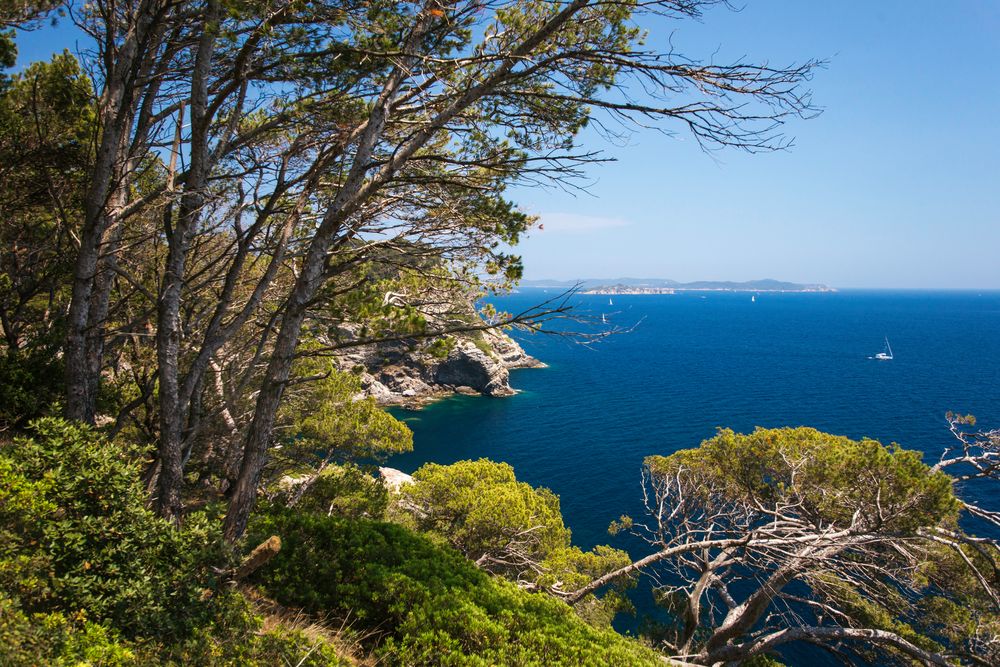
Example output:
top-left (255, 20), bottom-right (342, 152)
top-left (387, 289), bottom-right (1000, 648)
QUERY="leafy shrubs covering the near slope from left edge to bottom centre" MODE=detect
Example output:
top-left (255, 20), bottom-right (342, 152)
top-left (0, 419), bottom-right (657, 666)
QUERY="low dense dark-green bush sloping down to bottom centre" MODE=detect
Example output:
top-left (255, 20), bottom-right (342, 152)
top-left (251, 512), bottom-right (658, 665)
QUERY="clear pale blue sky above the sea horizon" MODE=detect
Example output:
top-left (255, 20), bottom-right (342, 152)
top-left (18, 0), bottom-right (1000, 289)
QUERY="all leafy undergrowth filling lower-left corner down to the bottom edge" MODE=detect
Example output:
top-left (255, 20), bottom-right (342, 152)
top-left (0, 419), bottom-right (360, 667)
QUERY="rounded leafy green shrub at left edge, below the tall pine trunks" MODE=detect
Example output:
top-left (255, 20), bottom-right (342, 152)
top-left (0, 418), bottom-right (226, 639)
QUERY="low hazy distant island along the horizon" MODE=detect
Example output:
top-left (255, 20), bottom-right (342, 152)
top-left (521, 278), bottom-right (837, 294)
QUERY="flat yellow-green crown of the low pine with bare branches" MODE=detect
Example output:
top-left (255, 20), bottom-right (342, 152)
top-left (646, 428), bottom-right (958, 533)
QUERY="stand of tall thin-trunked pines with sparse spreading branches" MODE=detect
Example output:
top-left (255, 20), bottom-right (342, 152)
top-left (0, 0), bottom-right (816, 540)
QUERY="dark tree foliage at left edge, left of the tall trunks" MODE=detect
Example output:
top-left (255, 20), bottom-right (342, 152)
top-left (0, 53), bottom-right (95, 360)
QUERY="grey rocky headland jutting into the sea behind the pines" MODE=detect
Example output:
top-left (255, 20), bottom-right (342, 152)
top-left (338, 330), bottom-right (545, 409)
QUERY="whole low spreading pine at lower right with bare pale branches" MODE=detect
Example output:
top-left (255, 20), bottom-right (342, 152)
top-left (584, 428), bottom-right (1000, 664)
